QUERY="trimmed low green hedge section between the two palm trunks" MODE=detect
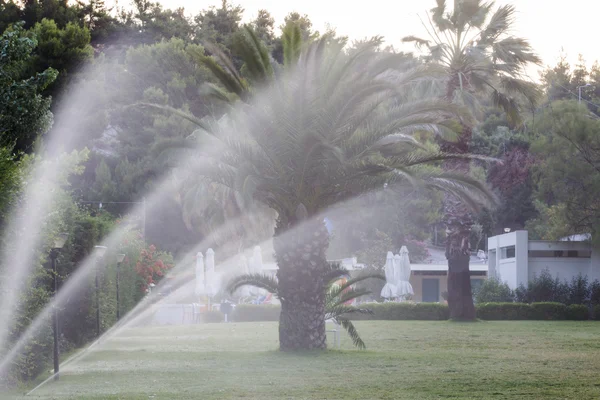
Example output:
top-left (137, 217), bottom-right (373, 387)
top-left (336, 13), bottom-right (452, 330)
top-left (352, 303), bottom-right (450, 321)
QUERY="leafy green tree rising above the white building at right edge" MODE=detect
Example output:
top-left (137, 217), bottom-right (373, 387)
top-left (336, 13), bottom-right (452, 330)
top-left (532, 101), bottom-right (600, 240)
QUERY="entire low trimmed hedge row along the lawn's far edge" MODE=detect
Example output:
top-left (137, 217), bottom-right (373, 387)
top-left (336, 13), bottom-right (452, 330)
top-left (229, 302), bottom-right (600, 322)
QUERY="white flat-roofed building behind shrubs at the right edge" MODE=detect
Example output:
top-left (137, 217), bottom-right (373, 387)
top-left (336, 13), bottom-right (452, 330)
top-left (488, 231), bottom-right (600, 289)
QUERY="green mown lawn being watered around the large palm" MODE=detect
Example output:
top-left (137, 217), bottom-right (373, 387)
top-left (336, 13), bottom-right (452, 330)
top-left (0, 321), bottom-right (600, 400)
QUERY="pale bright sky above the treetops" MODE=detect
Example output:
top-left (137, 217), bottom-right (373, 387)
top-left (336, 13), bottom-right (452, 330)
top-left (121, 0), bottom-right (600, 80)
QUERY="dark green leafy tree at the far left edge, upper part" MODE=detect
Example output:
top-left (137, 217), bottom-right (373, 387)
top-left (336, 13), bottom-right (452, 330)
top-left (0, 24), bottom-right (57, 151)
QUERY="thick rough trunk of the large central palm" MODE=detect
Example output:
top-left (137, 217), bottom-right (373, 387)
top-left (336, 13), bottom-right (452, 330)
top-left (273, 218), bottom-right (329, 351)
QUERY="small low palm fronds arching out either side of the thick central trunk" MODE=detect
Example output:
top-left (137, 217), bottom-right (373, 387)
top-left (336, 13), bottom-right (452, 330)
top-left (228, 263), bottom-right (385, 349)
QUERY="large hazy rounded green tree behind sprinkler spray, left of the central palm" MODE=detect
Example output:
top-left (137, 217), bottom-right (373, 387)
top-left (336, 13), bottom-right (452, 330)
top-left (69, 38), bottom-right (217, 253)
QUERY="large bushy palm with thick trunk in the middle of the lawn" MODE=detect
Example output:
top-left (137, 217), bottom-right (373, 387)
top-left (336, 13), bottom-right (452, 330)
top-left (188, 39), bottom-right (492, 350)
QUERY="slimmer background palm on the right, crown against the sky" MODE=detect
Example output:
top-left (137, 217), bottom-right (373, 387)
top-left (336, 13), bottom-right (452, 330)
top-left (403, 0), bottom-right (540, 320)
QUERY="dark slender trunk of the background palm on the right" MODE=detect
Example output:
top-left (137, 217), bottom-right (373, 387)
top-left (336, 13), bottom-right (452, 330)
top-left (440, 119), bottom-right (475, 320)
